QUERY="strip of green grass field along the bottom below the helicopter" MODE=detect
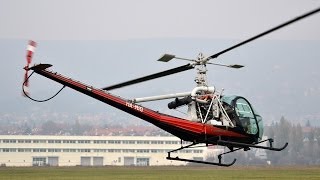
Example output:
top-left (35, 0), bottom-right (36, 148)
top-left (0, 166), bottom-right (320, 180)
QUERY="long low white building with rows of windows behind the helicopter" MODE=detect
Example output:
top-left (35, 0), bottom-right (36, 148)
top-left (0, 135), bottom-right (221, 166)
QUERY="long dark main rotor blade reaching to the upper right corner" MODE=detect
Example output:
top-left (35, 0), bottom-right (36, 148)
top-left (207, 7), bottom-right (320, 61)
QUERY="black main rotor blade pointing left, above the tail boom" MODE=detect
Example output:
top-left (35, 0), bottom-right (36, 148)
top-left (102, 64), bottom-right (194, 91)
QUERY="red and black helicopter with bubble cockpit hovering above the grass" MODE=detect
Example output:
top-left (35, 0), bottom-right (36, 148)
top-left (22, 7), bottom-right (320, 167)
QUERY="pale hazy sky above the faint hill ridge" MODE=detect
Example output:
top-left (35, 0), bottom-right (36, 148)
top-left (0, 0), bottom-right (320, 40)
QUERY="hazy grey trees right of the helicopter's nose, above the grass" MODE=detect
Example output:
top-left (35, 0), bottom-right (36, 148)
top-left (266, 117), bottom-right (320, 165)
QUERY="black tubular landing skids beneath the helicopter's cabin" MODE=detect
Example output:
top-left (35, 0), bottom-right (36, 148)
top-left (167, 139), bottom-right (288, 167)
